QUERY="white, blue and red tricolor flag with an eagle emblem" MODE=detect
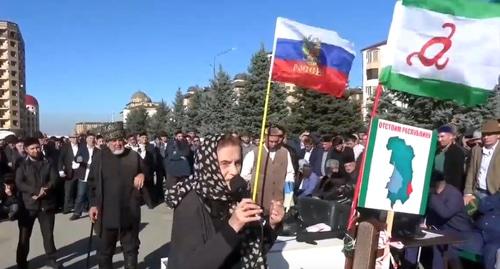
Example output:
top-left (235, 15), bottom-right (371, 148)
top-left (272, 18), bottom-right (355, 97)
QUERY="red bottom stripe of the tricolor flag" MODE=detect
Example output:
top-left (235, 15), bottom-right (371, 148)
top-left (272, 59), bottom-right (347, 97)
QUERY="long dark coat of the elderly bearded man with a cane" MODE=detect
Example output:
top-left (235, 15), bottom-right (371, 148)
top-left (88, 149), bottom-right (148, 232)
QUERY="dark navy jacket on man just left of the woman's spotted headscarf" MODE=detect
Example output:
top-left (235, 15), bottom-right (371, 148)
top-left (164, 140), bottom-right (193, 177)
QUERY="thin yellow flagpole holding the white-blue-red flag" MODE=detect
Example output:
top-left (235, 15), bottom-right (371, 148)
top-left (252, 30), bottom-right (276, 203)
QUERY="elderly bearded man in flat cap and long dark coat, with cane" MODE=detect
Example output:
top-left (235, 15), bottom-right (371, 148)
top-left (88, 129), bottom-right (147, 269)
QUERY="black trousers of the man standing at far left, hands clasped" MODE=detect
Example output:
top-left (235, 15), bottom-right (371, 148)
top-left (16, 210), bottom-right (57, 268)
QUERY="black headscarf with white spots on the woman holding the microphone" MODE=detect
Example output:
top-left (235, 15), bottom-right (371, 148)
top-left (165, 135), bottom-right (266, 268)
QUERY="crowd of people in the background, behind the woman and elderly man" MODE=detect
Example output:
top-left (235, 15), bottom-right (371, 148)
top-left (0, 120), bottom-right (500, 268)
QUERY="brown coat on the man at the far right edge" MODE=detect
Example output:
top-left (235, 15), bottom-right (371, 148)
top-left (464, 143), bottom-right (500, 194)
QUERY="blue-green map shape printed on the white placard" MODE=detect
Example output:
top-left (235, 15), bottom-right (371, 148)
top-left (386, 137), bottom-right (415, 207)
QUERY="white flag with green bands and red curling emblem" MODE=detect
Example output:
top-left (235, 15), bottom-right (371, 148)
top-left (380, 0), bottom-right (500, 106)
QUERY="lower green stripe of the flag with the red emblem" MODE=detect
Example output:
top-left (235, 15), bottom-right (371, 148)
top-left (380, 66), bottom-right (492, 106)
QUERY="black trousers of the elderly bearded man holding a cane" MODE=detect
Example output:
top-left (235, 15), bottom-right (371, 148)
top-left (97, 223), bottom-right (141, 269)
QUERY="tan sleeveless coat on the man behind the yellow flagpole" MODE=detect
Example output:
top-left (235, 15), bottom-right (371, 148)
top-left (251, 147), bottom-right (288, 213)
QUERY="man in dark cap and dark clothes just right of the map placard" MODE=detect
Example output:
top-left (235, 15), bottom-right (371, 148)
top-left (434, 124), bottom-right (465, 191)
